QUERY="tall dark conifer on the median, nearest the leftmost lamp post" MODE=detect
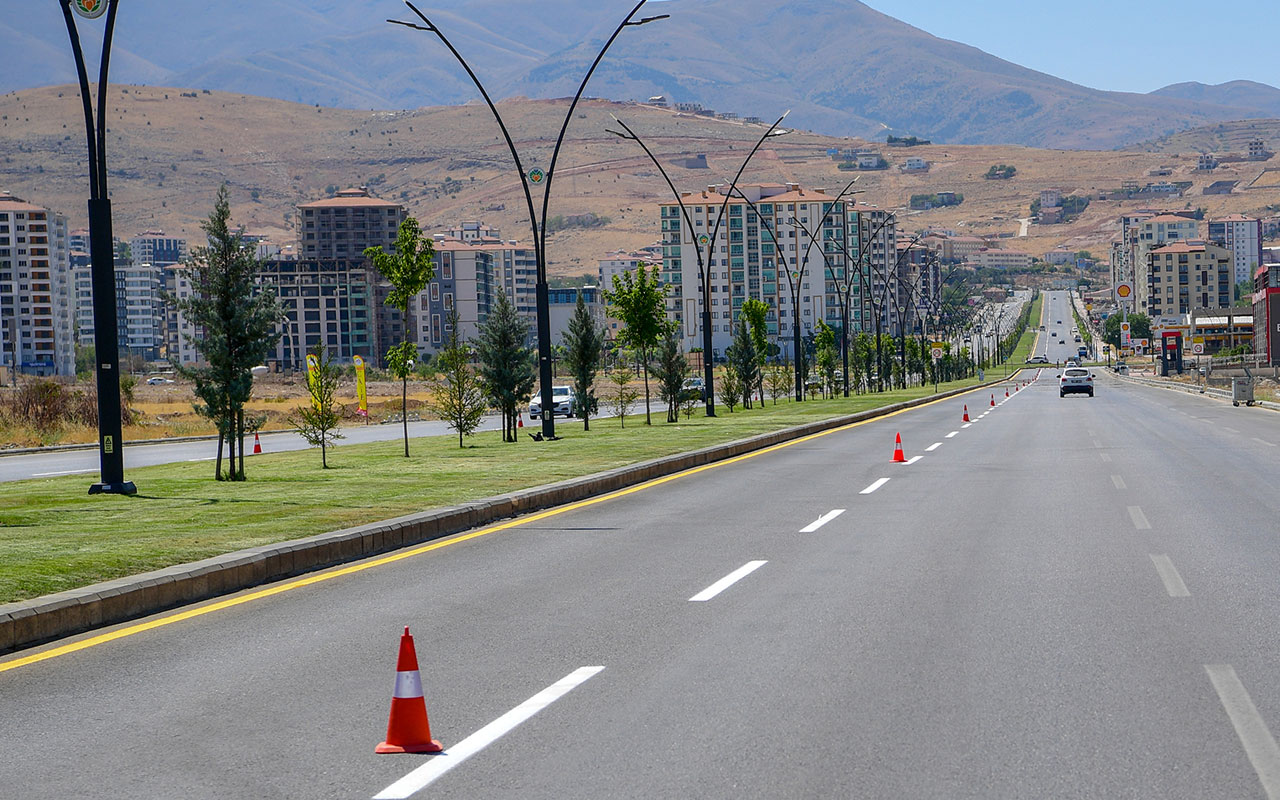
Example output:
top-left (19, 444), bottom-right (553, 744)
top-left (165, 184), bottom-right (284, 480)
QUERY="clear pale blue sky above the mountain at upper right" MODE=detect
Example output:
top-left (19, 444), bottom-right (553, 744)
top-left (863, 0), bottom-right (1280, 92)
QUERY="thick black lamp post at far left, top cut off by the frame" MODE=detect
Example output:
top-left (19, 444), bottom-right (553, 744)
top-left (59, 0), bottom-right (138, 494)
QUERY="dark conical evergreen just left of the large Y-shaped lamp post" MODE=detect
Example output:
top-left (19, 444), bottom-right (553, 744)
top-left (475, 289), bottom-right (540, 442)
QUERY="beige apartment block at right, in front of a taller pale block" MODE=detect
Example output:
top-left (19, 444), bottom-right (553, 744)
top-left (1135, 242), bottom-right (1234, 317)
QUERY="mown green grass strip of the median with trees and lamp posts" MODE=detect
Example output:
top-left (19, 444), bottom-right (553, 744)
top-left (0, 380), bottom-right (1003, 603)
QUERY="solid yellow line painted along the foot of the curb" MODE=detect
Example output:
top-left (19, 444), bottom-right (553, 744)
top-left (0, 387), bottom-right (984, 672)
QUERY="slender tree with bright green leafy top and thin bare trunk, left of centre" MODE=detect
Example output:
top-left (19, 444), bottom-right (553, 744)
top-left (365, 216), bottom-right (435, 458)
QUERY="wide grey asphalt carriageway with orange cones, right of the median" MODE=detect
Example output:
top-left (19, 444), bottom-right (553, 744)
top-left (0, 366), bottom-right (1280, 800)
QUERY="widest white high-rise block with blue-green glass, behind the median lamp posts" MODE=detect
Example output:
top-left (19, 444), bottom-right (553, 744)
top-left (660, 183), bottom-right (900, 357)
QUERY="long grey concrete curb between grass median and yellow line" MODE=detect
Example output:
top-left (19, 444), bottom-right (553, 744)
top-left (0, 371), bottom-right (1018, 653)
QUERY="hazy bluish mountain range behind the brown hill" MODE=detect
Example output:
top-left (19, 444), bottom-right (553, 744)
top-left (10, 0), bottom-right (1280, 150)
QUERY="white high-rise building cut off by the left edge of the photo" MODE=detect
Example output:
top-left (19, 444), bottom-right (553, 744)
top-left (0, 193), bottom-right (76, 375)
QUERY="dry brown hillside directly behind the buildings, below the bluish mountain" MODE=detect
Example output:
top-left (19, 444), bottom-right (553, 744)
top-left (0, 86), bottom-right (1280, 275)
